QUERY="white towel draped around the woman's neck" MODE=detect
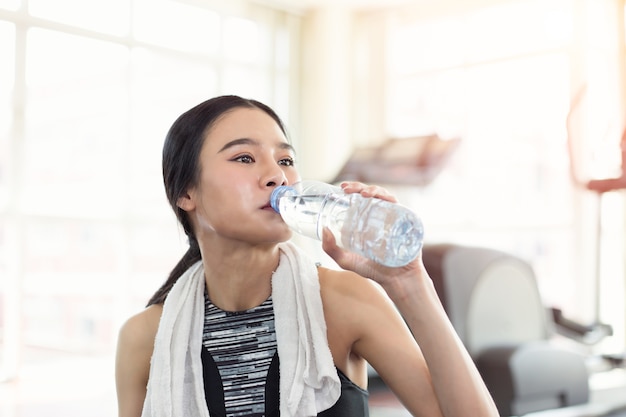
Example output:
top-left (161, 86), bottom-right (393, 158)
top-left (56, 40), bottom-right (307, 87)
top-left (142, 242), bottom-right (341, 417)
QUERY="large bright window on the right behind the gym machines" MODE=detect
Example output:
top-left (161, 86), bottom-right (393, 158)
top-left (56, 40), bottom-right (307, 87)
top-left (386, 0), bottom-right (625, 352)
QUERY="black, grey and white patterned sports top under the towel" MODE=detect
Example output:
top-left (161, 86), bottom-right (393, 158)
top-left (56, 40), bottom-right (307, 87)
top-left (202, 297), bottom-right (369, 417)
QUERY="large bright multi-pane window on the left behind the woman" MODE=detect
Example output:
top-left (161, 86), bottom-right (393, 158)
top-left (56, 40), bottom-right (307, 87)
top-left (0, 0), bottom-right (299, 378)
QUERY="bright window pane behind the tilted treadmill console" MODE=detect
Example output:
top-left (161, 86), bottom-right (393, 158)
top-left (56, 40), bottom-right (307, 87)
top-left (390, 55), bottom-right (572, 228)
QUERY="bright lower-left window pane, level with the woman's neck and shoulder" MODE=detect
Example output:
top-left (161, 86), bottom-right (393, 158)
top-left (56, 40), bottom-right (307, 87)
top-left (22, 219), bottom-right (124, 351)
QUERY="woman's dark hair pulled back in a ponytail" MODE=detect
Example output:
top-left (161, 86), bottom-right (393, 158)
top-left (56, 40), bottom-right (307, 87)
top-left (148, 95), bottom-right (287, 306)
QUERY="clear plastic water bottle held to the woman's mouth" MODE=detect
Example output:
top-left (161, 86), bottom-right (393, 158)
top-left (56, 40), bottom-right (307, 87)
top-left (270, 180), bottom-right (424, 267)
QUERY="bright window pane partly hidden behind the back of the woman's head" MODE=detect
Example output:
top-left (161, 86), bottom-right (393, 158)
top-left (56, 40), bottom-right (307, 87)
top-left (128, 48), bottom-right (217, 217)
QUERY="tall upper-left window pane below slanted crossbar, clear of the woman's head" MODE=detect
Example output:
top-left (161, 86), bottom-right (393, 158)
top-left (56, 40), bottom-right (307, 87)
top-left (21, 30), bottom-right (128, 217)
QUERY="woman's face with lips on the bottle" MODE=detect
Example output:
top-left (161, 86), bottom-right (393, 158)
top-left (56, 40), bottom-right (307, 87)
top-left (178, 108), bottom-right (299, 244)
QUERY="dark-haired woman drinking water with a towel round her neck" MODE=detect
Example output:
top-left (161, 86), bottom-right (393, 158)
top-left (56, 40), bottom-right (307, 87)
top-left (116, 96), bottom-right (498, 417)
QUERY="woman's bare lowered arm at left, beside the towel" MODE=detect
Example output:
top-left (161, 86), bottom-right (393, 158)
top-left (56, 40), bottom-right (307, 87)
top-left (115, 305), bottom-right (162, 417)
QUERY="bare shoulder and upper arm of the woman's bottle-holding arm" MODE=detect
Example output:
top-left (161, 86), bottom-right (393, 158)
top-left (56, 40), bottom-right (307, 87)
top-left (320, 264), bottom-right (443, 417)
